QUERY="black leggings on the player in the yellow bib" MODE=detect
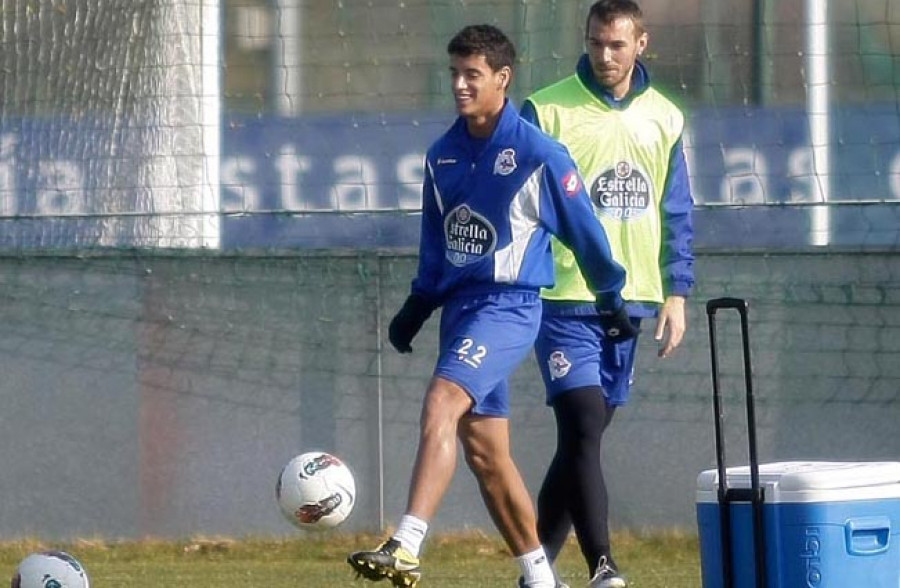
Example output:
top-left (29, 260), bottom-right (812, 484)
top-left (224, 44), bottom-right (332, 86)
top-left (538, 386), bottom-right (615, 574)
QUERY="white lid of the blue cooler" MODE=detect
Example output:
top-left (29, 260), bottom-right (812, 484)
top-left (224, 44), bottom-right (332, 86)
top-left (697, 461), bottom-right (900, 502)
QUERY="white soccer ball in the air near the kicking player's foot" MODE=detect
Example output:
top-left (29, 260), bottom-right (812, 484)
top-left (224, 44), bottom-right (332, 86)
top-left (275, 451), bottom-right (356, 529)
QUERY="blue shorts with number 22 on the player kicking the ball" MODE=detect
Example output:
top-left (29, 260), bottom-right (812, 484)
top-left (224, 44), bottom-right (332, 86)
top-left (434, 291), bottom-right (541, 417)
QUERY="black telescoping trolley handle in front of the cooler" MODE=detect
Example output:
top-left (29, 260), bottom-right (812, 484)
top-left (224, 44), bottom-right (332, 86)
top-left (706, 298), bottom-right (767, 588)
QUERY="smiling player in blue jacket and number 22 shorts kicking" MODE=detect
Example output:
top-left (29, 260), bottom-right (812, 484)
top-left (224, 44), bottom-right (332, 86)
top-left (348, 25), bottom-right (636, 588)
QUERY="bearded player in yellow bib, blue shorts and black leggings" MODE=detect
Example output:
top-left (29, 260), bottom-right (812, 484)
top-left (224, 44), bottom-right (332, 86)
top-left (521, 0), bottom-right (694, 588)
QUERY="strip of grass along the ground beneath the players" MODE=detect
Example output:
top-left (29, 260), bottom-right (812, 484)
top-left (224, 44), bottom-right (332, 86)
top-left (0, 532), bottom-right (700, 588)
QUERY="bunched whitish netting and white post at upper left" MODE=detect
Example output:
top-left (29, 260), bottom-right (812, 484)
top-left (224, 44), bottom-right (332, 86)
top-left (0, 0), bottom-right (219, 248)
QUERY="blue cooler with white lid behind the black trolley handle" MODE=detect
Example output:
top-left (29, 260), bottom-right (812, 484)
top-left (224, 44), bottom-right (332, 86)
top-left (697, 461), bottom-right (900, 588)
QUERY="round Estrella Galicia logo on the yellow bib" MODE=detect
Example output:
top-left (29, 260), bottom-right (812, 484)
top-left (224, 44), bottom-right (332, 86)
top-left (591, 161), bottom-right (652, 221)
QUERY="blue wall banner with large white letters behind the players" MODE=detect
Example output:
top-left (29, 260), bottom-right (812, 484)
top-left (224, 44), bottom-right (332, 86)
top-left (0, 105), bottom-right (900, 249)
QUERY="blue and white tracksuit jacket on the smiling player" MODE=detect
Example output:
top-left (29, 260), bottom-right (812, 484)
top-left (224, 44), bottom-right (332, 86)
top-left (412, 101), bottom-right (625, 307)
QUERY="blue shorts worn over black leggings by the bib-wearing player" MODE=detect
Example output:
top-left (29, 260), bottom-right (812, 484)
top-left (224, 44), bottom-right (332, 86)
top-left (534, 313), bottom-right (640, 406)
